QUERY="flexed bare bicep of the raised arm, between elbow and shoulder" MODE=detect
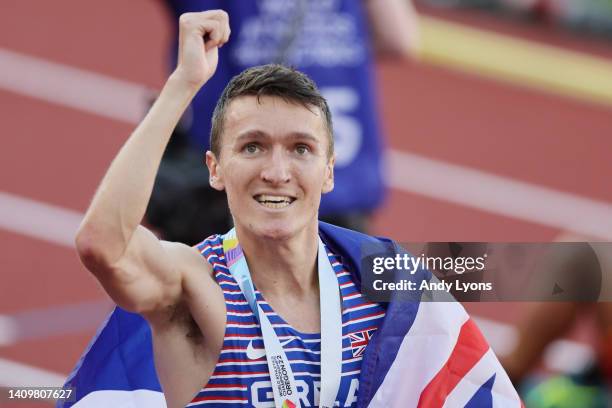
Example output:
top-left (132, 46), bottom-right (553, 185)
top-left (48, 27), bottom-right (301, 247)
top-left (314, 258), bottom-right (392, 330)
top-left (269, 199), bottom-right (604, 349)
top-left (88, 226), bottom-right (195, 314)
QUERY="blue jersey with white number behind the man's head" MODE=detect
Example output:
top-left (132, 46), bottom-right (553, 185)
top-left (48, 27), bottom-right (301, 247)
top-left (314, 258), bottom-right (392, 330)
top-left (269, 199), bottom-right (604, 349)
top-left (167, 0), bottom-right (384, 216)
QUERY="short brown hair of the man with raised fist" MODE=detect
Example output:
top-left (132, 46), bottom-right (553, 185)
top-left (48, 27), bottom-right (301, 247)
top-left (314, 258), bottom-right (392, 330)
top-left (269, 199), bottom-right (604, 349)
top-left (210, 64), bottom-right (334, 158)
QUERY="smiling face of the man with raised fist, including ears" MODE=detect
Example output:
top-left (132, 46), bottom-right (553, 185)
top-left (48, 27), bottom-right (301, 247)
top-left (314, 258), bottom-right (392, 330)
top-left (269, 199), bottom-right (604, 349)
top-left (206, 96), bottom-right (333, 239)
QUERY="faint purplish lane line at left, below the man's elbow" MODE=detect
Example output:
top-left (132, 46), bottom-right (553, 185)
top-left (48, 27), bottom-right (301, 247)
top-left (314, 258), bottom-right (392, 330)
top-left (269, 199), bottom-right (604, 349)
top-left (0, 300), bottom-right (113, 347)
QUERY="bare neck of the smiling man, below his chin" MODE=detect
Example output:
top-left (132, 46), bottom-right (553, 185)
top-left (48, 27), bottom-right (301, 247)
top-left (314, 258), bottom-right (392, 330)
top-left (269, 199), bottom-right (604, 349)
top-left (236, 223), bottom-right (319, 297)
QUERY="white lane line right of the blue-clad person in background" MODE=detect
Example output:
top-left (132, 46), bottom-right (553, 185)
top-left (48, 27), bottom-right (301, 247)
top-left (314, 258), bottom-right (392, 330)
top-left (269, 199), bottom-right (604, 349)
top-left (387, 150), bottom-right (612, 240)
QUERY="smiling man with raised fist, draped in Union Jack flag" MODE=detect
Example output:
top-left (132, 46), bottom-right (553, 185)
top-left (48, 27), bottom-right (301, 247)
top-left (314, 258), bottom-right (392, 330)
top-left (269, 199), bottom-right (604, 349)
top-left (68, 11), bottom-right (517, 407)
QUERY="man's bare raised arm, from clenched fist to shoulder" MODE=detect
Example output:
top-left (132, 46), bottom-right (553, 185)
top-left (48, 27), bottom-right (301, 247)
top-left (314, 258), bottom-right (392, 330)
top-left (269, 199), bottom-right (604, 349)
top-left (76, 10), bottom-right (230, 314)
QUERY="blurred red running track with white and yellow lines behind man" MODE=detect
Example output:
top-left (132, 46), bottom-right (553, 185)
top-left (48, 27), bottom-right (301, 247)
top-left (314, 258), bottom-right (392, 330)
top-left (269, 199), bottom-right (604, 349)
top-left (0, 0), bottom-right (612, 407)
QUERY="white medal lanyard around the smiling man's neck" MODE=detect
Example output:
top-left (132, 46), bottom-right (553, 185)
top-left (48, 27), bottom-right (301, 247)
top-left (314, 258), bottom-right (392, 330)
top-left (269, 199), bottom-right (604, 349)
top-left (223, 229), bottom-right (342, 408)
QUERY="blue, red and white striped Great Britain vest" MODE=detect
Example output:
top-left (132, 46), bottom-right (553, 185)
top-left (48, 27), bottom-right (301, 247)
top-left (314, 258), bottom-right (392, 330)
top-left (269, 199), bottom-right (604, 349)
top-left (187, 235), bottom-right (385, 408)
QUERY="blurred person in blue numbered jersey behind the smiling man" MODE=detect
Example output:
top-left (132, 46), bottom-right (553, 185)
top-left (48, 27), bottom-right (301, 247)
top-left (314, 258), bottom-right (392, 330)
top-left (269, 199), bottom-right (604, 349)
top-left (147, 0), bottom-right (419, 245)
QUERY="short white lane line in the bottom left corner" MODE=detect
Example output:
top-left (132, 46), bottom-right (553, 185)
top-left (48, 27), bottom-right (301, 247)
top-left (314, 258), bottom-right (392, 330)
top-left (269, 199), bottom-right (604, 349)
top-left (0, 358), bottom-right (66, 387)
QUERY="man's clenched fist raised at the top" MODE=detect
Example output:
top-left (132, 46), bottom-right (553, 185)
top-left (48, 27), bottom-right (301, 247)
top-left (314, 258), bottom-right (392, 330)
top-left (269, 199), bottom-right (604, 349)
top-left (175, 10), bottom-right (230, 89)
